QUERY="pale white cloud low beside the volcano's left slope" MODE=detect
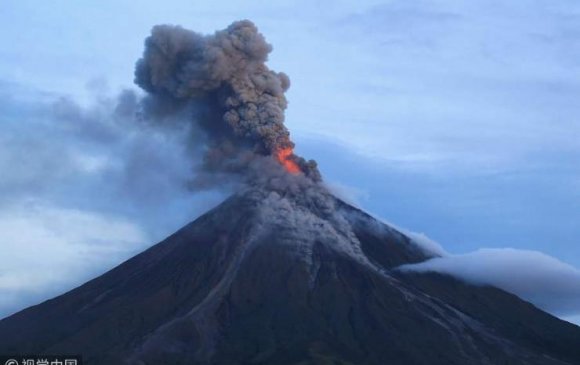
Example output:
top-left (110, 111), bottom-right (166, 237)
top-left (0, 201), bottom-right (150, 318)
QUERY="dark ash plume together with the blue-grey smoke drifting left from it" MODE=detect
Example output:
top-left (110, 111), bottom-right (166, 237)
top-left (0, 21), bottom-right (320, 219)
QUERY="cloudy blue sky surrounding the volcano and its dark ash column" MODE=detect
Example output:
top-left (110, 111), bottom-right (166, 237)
top-left (0, 0), bottom-right (580, 323)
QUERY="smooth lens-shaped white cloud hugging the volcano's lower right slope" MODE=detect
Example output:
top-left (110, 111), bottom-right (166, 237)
top-left (400, 248), bottom-right (580, 317)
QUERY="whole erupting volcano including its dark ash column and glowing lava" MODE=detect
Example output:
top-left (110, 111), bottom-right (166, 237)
top-left (0, 21), bottom-right (580, 365)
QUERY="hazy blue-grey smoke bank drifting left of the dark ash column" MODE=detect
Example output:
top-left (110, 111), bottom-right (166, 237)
top-left (0, 86), bottom-right (192, 199)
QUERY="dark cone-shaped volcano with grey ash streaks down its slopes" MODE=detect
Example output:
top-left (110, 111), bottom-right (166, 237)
top-left (0, 188), bottom-right (580, 365)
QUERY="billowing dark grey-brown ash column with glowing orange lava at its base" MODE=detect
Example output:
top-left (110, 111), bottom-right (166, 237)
top-left (135, 20), bottom-right (320, 186)
